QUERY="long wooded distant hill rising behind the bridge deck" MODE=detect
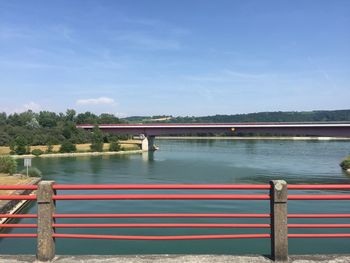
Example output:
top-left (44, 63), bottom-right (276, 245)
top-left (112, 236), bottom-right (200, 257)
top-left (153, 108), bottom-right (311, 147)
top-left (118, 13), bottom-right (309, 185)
top-left (124, 110), bottom-right (350, 123)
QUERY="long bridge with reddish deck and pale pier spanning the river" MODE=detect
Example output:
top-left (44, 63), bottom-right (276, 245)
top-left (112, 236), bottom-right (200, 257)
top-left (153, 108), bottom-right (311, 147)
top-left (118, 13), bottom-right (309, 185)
top-left (77, 122), bottom-right (350, 150)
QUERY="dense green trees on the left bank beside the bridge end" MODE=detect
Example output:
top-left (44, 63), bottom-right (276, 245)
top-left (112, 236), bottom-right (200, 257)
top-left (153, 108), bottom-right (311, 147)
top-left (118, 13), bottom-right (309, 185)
top-left (0, 109), bottom-right (125, 154)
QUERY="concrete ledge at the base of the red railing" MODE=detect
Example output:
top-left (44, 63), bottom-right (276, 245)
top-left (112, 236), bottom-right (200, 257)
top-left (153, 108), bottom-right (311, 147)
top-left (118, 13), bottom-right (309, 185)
top-left (0, 255), bottom-right (350, 263)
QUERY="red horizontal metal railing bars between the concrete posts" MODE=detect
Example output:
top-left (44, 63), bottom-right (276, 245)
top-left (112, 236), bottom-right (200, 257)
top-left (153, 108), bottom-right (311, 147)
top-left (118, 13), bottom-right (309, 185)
top-left (0, 183), bottom-right (350, 262)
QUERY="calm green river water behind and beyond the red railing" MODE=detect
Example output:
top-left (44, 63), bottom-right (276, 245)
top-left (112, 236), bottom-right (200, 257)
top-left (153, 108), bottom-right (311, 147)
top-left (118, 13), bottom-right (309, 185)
top-left (0, 140), bottom-right (350, 254)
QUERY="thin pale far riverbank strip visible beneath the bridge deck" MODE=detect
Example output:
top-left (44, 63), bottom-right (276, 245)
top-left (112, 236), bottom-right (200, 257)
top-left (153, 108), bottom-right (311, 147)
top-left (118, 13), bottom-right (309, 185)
top-left (156, 136), bottom-right (350, 141)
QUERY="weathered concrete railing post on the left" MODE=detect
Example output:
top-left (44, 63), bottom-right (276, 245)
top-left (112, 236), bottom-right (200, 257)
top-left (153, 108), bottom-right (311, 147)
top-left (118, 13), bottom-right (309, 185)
top-left (36, 181), bottom-right (55, 261)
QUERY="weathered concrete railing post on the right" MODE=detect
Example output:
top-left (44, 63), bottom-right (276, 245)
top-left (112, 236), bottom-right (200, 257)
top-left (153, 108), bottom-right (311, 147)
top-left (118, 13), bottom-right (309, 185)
top-left (270, 180), bottom-right (288, 261)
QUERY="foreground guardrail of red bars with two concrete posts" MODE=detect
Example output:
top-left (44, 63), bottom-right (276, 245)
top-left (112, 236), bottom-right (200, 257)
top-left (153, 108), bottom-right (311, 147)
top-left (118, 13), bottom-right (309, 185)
top-left (0, 180), bottom-right (350, 261)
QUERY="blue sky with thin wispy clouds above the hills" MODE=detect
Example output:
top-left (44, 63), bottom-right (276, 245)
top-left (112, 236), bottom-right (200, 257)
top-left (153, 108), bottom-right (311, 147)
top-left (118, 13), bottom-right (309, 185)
top-left (0, 0), bottom-right (350, 116)
